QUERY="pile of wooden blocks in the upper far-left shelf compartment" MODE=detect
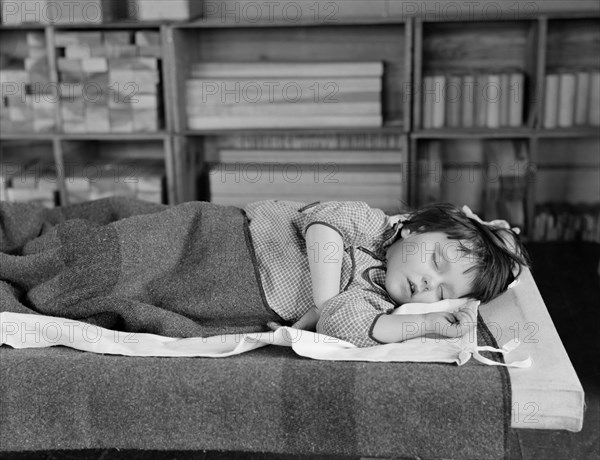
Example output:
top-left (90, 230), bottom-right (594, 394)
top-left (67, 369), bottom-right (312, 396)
top-left (0, 31), bottom-right (56, 132)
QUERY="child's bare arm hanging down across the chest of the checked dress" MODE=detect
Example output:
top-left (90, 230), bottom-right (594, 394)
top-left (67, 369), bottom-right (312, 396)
top-left (293, 224), bottom-right (344, 330)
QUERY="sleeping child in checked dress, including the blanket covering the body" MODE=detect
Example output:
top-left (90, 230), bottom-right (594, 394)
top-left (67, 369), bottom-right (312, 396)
top-left (0, 198), bottom-right (527, 347)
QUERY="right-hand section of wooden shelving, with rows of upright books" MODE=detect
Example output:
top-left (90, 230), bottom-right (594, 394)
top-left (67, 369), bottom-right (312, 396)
top-left (410, 11), bottom-right (600, 238)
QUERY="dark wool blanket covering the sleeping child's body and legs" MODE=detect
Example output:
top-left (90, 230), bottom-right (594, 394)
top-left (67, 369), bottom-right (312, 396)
top-left (0, 198), bottom-right (281, 337)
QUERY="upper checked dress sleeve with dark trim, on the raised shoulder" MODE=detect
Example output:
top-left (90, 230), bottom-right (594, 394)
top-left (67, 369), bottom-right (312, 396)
top-left (302, 201), bottom-right (388, 246)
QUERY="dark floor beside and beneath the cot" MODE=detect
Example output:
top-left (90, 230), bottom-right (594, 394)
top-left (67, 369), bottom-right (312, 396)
top-left (3, 243), bottom-right (600, 460)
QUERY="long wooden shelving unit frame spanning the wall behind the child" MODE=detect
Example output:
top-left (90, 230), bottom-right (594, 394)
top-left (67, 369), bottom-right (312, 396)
top-left (0, 0), bottom-right (600, 239)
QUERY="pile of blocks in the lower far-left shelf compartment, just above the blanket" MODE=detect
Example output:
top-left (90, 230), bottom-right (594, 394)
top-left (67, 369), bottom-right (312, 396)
top-left (0, 159), bottom-right (58, 207)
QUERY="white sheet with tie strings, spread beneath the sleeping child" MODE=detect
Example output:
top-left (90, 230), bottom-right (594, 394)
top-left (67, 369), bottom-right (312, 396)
top-left (0, 300), bottom-right (531, 367)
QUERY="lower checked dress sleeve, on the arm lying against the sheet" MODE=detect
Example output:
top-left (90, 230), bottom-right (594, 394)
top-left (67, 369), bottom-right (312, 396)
top-left (317, 289), bottom-right (393, 347)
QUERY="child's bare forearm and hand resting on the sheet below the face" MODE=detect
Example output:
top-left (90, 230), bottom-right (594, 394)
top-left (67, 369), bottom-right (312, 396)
top-left (372, 307), bottom-right (477, 343)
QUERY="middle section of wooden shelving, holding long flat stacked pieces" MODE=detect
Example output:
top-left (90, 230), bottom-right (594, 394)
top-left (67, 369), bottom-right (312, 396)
top-left (167, 18), bottom-right (413, 204)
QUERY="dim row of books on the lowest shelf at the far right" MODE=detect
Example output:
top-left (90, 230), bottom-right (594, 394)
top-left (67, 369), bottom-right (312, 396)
top-left (532, 203), bottom-right (600, 243)
